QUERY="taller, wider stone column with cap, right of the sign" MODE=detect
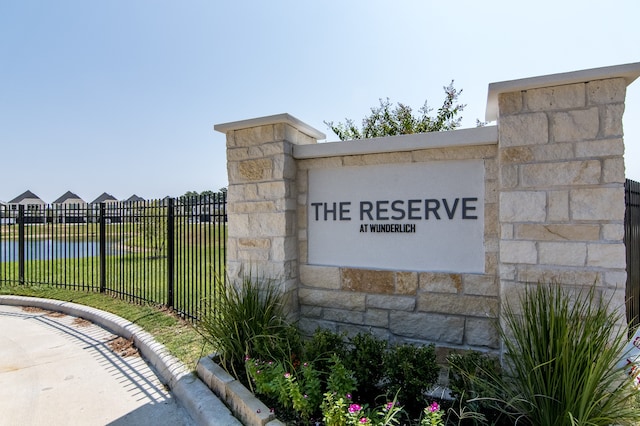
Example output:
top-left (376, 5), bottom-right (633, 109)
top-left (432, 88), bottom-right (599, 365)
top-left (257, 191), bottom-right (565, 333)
top-left (488, 64), bottom-right (640, 320)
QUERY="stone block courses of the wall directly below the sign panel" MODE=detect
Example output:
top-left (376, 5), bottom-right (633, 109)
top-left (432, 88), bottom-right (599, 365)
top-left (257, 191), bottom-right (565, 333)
top-left (299, 265), bottom-right (499, 350)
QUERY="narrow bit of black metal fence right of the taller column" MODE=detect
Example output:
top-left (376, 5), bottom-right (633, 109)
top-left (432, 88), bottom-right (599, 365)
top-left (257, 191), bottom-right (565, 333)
top-left (624, 179), bottom-right (640, 330)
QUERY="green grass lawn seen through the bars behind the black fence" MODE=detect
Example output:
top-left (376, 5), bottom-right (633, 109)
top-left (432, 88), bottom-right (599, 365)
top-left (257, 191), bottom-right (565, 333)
top-left (0, 223), bottom-right (226, 317)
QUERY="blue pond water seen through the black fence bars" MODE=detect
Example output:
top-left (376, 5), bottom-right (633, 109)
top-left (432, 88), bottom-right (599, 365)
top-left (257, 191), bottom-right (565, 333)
top-left (0, 240), bottom-right (110, 262)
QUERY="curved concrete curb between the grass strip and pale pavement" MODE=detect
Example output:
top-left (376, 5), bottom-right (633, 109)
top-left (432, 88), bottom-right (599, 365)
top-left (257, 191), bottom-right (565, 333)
top-left (0, 296), bottom-right (242, 426)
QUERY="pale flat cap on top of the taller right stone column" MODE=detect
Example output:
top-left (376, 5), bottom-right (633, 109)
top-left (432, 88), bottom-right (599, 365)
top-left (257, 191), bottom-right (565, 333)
top-left (485, 62), bottom-right (640, 121)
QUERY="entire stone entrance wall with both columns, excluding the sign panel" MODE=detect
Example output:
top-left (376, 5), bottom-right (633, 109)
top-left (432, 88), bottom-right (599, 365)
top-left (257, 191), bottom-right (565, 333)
top-left (215, 64), bottom-right (640, 354)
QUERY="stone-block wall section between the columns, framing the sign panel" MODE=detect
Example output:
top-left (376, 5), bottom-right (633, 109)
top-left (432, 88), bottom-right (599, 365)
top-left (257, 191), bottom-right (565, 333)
top-left (298, 140), bottom-right (500, 349)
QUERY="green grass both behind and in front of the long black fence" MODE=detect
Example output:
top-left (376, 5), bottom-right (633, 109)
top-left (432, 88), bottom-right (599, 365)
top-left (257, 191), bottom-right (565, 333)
top-left (0, 223), bottom-right (226, 369)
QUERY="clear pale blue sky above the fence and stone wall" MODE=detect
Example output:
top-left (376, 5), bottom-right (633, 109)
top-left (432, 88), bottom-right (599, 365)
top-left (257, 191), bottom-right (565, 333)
top-left (0, 0), bottom-right (640, 202)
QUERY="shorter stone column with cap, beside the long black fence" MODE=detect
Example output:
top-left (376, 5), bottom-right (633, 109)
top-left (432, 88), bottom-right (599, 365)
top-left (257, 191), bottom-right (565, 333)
top-left (214, 114), bottom-right (325, 310)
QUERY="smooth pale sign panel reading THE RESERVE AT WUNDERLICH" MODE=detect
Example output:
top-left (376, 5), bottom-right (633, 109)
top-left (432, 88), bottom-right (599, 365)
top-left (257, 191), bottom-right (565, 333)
top-left (307, 160), bottom-right (485, 273)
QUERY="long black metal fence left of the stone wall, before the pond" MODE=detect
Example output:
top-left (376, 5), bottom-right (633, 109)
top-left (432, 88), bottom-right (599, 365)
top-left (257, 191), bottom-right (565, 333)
top-left (0, 193), bottom-right (227, 319)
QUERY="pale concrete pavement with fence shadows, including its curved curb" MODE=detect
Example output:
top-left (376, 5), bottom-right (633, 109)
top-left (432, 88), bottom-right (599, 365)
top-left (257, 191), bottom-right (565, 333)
top-left (0, 296), bottom-right (240, 426)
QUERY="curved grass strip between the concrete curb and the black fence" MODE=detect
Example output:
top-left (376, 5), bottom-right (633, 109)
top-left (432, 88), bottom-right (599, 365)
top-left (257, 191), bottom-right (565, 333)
top-left (0, 283), bottom-right (213, 370)
